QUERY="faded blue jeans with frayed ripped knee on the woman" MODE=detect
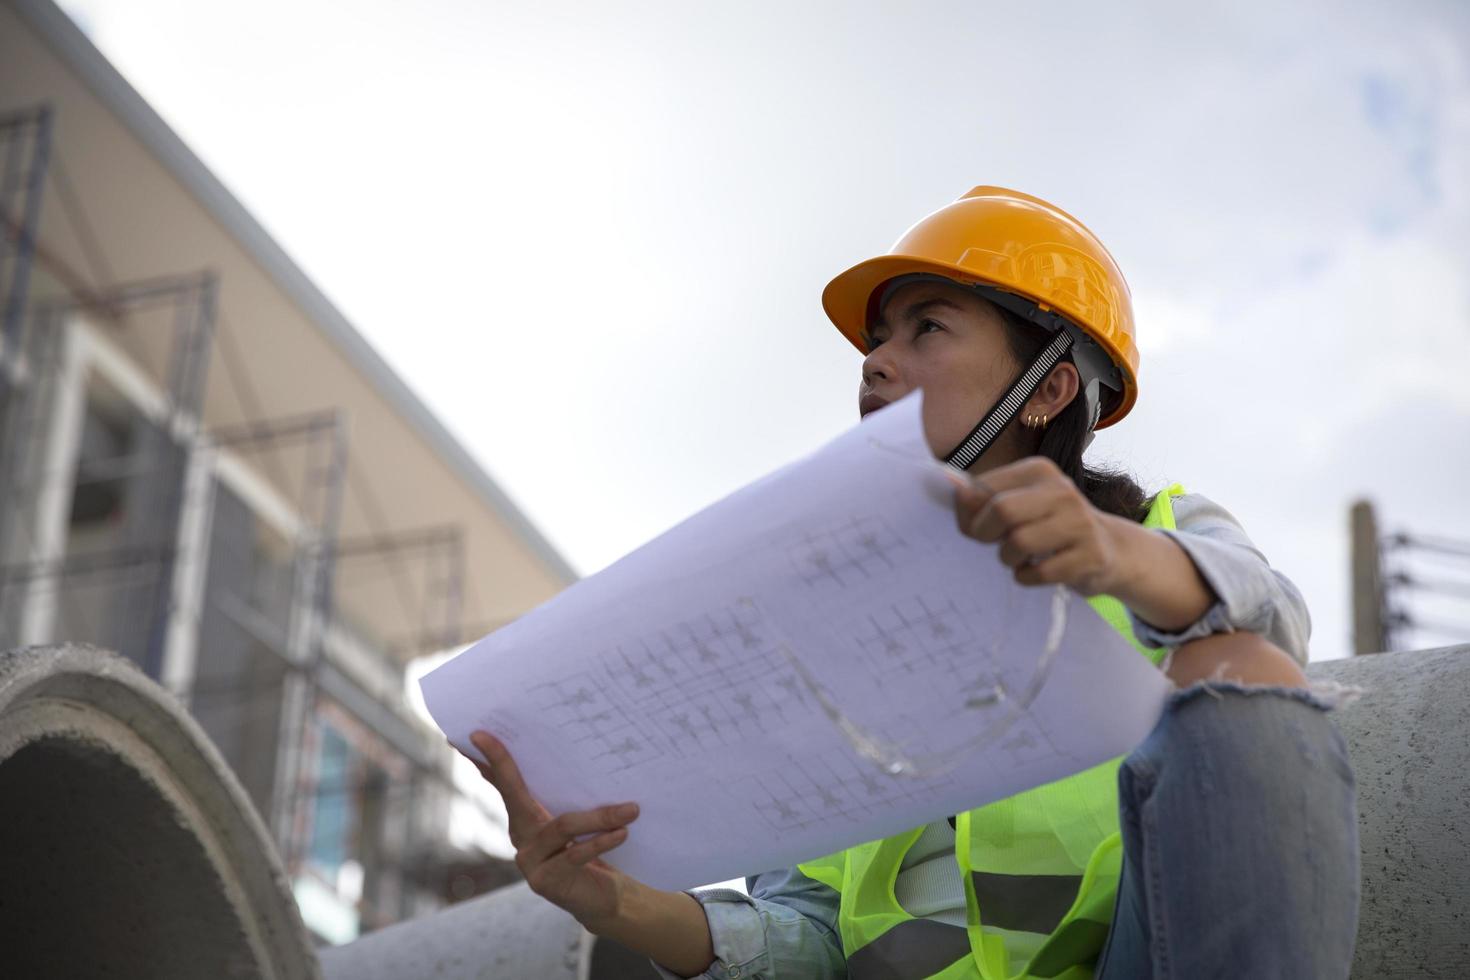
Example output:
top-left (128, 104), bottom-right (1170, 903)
top-left (1097, 683), bottom-right (1358, 980)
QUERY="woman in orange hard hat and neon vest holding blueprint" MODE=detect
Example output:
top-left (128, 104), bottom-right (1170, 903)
top-left (473, 187), bottom-right (1358, 980)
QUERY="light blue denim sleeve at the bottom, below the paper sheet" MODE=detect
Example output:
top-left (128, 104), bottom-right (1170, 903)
top-left (654, 868), bottom-right (847, 980)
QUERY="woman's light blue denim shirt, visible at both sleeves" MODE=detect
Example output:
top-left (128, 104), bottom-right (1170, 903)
top-left (654, 494), bottom-right (1311, 980)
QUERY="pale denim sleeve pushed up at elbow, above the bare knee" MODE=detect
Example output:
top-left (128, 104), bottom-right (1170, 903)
top-left (1133, 494), bottom-right (1311, 664)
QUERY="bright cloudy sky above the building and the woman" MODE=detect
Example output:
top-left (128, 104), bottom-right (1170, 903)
top-left (65, 0), bottom-right (1470, 858)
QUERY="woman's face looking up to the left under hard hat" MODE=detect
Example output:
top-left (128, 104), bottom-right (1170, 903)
top-left (857, 282), bottom-right (1022, 470)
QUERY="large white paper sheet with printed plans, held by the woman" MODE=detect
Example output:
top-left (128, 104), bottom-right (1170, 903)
top-left (422, 394), bottom-right (1167, 889)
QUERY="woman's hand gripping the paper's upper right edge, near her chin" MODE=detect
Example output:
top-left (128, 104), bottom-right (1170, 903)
top-left (954, 455), bottom-right (1125, 595)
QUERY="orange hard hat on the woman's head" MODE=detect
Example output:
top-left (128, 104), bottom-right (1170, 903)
top-left (822, 187), bottom-right (1138, 429)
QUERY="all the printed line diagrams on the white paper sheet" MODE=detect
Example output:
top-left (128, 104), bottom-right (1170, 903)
top-left (531, 552), bottom-right (1055, 787)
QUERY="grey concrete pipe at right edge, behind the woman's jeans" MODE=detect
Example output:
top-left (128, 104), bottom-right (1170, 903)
top-left (1307, 645), bottom-right (1470, 980)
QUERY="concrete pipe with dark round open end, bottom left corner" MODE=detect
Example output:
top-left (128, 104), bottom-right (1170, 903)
top-left (0, 646), bottom-right (320, 980)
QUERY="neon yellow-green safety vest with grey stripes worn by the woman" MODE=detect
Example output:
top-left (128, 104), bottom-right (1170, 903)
top-left (798, 485), bottom-right (1183, 980)
